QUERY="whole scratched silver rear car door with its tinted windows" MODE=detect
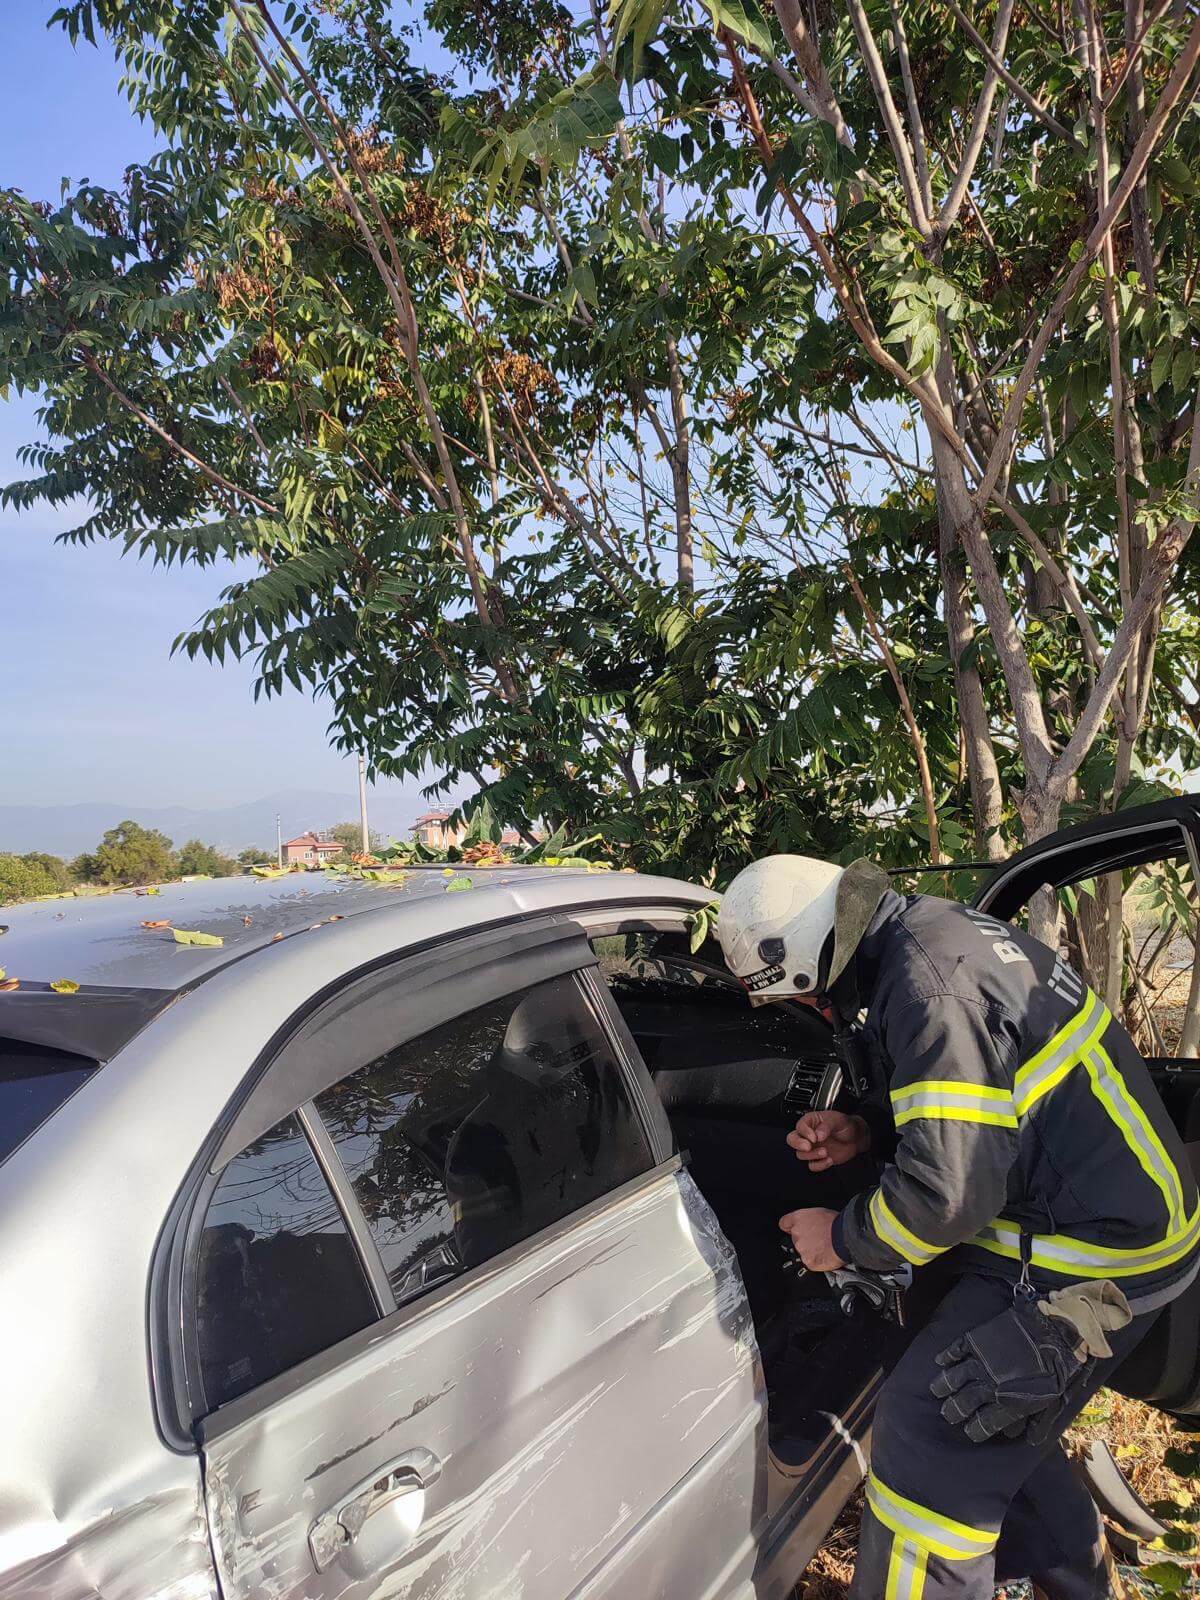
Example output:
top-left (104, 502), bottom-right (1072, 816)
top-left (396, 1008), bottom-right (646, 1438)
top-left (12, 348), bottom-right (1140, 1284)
top-left (181, 923), bottom-right (763, 1600)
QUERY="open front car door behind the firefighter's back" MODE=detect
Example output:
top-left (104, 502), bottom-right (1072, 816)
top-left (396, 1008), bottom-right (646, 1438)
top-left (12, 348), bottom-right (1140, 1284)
top-left (974, 795), bottom-right (1200, 1418)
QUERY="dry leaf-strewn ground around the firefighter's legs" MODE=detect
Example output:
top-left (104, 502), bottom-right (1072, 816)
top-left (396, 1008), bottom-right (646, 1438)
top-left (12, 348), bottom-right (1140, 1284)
top-left (794, 1389), bottom-right (1194, 1600)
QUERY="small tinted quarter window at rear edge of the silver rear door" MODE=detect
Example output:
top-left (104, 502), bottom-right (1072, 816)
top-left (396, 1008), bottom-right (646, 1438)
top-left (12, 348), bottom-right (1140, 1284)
top-left (197, 1117), bottom-right (378, 1410)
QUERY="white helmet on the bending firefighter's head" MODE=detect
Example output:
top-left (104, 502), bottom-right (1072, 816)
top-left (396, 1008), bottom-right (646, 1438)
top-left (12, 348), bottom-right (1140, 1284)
top-left (717, 856), bottom-right (888, 1005)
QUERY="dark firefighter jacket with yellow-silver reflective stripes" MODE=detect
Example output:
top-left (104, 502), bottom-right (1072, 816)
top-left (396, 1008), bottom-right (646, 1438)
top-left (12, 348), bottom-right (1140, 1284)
top-left (834, 891), bottom-right (1200, 1301)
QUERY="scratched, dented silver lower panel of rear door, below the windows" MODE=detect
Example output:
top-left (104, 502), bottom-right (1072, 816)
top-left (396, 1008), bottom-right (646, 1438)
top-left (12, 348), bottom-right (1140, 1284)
top-left (203, 1171), bottom-right (765, 1600)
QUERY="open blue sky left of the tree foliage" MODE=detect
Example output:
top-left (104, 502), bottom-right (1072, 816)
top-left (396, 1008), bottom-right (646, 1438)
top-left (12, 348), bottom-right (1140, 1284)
top-left (0, 9), bottom-right (441, 812)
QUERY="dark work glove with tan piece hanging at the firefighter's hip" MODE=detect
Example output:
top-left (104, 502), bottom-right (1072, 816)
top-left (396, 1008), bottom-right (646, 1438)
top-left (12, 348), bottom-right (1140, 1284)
top-left (930, 1282), bottom-right (1131, 1445)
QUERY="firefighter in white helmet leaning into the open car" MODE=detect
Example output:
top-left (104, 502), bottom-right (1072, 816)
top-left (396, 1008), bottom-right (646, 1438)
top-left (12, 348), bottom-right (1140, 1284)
top-left (718, 856), bottom-right (1200, 1600)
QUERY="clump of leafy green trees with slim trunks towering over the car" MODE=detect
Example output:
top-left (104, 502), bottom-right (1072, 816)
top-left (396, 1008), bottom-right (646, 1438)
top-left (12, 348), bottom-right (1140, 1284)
top-left (0, 0), bottom-right (1200, 934)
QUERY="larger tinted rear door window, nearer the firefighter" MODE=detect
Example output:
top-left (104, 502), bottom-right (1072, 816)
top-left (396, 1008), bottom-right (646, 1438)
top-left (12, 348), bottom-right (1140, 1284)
top-left (317, 978), bottom-right (653, 1301)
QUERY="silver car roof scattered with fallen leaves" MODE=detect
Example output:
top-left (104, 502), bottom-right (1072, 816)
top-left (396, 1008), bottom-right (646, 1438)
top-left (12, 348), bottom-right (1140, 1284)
top-left (0, 866), bottom-right (714, 998)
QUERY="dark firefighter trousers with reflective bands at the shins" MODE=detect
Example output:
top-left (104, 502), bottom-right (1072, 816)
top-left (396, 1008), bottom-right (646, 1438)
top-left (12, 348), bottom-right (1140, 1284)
top-left (850, 1272), bottom-right (1155, 1600)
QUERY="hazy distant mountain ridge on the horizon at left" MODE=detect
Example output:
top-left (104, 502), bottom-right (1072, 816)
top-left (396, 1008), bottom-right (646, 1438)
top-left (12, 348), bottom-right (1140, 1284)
top-left (0, 784), bottom-right (460, 858)
